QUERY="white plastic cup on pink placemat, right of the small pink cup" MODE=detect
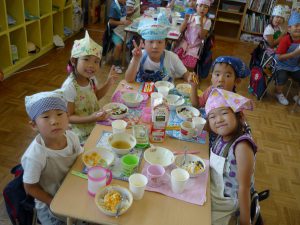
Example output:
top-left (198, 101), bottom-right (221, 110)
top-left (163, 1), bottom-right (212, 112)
top-left (171, 168), bottom-right (190, 194)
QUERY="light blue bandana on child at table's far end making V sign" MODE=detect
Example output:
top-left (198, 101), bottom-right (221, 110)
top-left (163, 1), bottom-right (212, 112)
top-left (138, 12), bottom-right (170, 40)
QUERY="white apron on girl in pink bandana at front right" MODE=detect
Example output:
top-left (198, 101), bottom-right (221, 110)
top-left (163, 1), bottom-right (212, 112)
top-left (209, 151), bottom-right (238, 225)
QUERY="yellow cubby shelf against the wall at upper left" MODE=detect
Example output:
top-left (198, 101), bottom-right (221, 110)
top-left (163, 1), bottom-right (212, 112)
top-left (0, 0), bottom-right (81, 78)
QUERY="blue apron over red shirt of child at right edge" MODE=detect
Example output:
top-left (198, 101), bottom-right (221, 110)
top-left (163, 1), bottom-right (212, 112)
top-left (276, 37), bottom-right (300, 72)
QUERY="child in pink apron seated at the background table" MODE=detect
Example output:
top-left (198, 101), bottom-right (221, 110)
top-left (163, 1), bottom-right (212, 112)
top-left (174, 0), bottom-right (211, 71)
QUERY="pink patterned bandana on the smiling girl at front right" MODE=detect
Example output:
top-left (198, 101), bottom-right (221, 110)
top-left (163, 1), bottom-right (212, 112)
top-left (205, 88), bottom-right (253, 115)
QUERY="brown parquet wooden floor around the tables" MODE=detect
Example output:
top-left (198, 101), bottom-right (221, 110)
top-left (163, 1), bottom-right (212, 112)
top-left (0, 23), bottom-right (300, 225)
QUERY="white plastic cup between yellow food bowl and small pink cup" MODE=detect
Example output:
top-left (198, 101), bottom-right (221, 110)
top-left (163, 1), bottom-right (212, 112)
top-left (128, 173), bottom-right (148, 200)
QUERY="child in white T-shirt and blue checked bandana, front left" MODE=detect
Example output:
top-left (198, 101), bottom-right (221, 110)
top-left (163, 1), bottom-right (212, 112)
top-left (21, 92), bottom-right (83, 225)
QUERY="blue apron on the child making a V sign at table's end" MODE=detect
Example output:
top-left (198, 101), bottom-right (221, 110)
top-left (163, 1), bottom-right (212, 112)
top-left (135, 51), bottom-right (173, 82)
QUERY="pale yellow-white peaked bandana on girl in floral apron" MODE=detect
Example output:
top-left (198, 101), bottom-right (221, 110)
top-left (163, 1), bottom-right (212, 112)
top-left (71, 31), bottom-right (102, 59)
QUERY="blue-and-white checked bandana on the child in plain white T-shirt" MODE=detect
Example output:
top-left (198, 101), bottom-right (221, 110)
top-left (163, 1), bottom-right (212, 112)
top-left (25, 90), bottom-right (67, 120)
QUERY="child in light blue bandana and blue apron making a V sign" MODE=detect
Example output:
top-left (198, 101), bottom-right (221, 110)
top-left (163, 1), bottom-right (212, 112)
top-left (125, 13), bottom-right (191, 82)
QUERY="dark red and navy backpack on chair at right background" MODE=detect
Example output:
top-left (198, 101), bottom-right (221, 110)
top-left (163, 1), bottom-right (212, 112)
top-left (248, 66), bottom-right (267, 100)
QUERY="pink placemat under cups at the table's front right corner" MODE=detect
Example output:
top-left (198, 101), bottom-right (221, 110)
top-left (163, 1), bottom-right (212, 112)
top-left (142, 159), bottom-right (209, 205)
